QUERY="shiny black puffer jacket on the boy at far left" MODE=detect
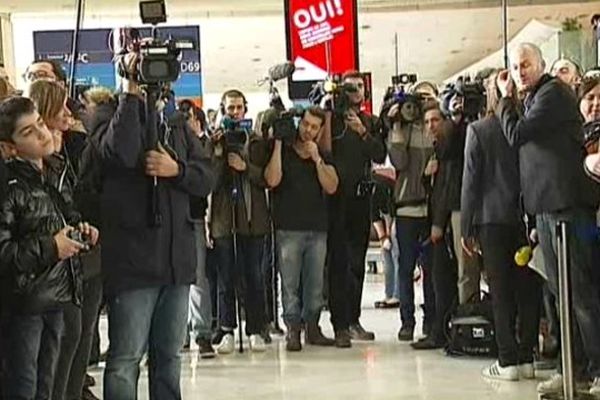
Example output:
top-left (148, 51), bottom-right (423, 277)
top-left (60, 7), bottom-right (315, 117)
top-left (0, 160), bottom-right (82, 313)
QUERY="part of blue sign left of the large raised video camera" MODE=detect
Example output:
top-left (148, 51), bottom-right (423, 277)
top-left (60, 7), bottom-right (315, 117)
top-left (33, 29), bottom-right (116, 88)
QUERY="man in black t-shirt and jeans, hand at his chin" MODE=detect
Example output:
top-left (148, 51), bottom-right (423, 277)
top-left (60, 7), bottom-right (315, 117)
top-left (265, 107), bottom-right (338, 351)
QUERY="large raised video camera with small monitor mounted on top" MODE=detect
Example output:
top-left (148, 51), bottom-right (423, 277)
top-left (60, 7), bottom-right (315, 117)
top-left (117, 0), bottom-right (196, 86)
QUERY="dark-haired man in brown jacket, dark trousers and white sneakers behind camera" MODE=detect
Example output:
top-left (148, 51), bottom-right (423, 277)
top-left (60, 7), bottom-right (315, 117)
top-left (210, 90), bottom-right (270, 354)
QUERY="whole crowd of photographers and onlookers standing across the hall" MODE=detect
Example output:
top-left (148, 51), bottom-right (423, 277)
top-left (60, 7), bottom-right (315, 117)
top-left (0, 38), bottom-right (600, 400)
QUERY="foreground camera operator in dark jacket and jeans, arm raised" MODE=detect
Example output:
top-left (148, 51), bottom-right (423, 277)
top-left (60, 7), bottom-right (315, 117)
top-left (93, 53), bottom-right (214, 400)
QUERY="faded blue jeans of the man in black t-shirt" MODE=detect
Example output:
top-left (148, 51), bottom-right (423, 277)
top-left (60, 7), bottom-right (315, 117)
top-left (277, 231), bottom-right (327, 326)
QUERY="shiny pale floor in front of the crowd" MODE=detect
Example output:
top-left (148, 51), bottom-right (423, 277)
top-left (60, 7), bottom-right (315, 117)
top-left (92, 276), bottom-right (537, 400)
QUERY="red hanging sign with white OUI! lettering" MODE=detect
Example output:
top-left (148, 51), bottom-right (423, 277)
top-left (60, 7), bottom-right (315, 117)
top-left (285, 0), bottom-right (359, 99)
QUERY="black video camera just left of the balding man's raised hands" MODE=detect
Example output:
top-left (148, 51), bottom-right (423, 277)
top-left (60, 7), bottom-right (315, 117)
top-left (442, 77), bottom-right (487, 121)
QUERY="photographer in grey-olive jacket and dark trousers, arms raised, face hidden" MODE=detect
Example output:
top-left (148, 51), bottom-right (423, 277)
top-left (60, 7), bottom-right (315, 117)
top-left (384, 82), bottom-right (438, 342)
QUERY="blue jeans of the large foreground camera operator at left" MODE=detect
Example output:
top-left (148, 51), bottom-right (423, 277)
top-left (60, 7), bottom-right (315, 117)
top-left (104, 286), bottom-right (189, 400)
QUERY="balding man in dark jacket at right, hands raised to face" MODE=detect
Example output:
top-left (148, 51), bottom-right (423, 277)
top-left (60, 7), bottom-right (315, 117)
top-left (496, 43), bottom-right (600, 394)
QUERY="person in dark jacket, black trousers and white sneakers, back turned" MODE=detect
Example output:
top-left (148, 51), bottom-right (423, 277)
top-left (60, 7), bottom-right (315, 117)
top-left (461, 72), bottom-right (542, 381)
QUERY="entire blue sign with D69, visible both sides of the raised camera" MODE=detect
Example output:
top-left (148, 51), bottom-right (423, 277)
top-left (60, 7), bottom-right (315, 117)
top-left (33, 26), bottom-right (202, 99)
